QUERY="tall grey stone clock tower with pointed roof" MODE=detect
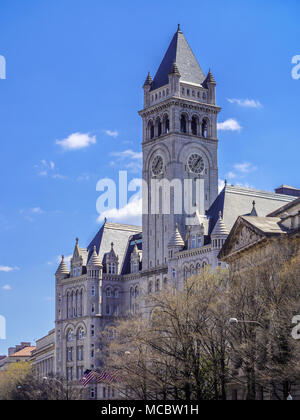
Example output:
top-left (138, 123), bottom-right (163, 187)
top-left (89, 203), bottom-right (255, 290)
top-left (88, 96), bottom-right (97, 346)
top-left (140, 26), bottom-right (220, 273)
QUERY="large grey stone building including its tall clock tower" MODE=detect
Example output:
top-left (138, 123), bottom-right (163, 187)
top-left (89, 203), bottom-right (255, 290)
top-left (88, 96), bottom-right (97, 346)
top-left (37, 28), bottom-right (300, 399)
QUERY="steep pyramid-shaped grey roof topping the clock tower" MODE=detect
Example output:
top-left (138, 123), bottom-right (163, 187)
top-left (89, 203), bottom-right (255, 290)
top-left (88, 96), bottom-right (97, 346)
top-left (151, 27), bottom-right (205, 90)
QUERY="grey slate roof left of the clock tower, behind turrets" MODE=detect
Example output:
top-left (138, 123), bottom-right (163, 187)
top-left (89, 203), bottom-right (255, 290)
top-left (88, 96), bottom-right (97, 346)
top-left (87, 222), bottom-right (142, 274)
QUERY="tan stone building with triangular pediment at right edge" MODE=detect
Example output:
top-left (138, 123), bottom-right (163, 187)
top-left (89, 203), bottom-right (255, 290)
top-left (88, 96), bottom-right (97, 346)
top-left (219, 198), bottom-right (300, 400)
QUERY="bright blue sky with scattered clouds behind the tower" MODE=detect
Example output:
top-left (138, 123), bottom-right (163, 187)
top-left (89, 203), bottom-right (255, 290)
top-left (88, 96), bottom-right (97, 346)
top-left (0, 0), bottom-right (300, 354)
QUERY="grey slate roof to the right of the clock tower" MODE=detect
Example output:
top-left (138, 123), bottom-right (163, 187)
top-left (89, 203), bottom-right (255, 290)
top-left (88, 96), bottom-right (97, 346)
top-left (207, 185), bottom-right (294, 235)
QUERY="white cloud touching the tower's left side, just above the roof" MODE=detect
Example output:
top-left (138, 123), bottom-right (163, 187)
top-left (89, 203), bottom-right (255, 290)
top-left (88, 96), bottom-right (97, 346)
top-left (98, 198), bottom-right (143, 225)
